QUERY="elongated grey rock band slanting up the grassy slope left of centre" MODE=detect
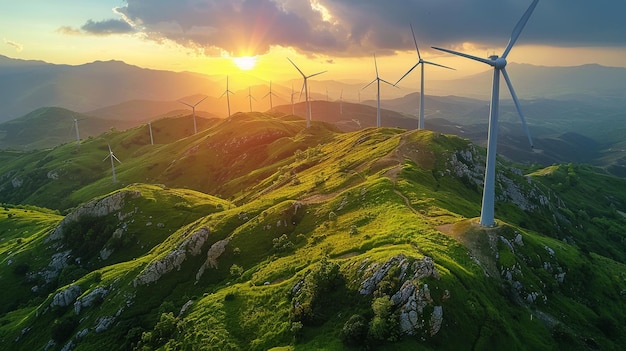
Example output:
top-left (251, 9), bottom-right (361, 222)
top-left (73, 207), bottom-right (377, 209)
top-left (133, 227), bottom-right (211, 287)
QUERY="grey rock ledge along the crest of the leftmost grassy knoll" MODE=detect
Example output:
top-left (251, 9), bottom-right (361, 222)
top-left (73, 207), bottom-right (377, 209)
top-left (46, 190), bottom-right (141, 242)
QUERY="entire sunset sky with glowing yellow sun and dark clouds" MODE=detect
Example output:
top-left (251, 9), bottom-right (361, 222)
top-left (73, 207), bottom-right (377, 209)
top-left (0, 0), bottom-right (626, 81)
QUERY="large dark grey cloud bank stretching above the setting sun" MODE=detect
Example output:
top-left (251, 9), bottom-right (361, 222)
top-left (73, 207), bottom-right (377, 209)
top-left (108, 0), bottom-right (626, 56)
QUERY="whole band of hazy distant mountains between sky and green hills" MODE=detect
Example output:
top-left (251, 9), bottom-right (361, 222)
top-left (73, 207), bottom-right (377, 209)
top-left (0, 56), bottom-right (626, 175)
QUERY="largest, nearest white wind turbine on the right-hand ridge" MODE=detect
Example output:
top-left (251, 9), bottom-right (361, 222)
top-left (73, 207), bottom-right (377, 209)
top-left (433, 0), bottom-right (539, 227)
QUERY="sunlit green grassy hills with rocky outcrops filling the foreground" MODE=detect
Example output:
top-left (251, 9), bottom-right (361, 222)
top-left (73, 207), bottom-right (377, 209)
top-left (0, 113), bottom-right (626, 350)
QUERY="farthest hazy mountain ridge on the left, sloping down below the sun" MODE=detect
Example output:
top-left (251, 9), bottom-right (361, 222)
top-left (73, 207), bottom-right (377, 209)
top-left (0, 56), bottom-right (221, 121)
